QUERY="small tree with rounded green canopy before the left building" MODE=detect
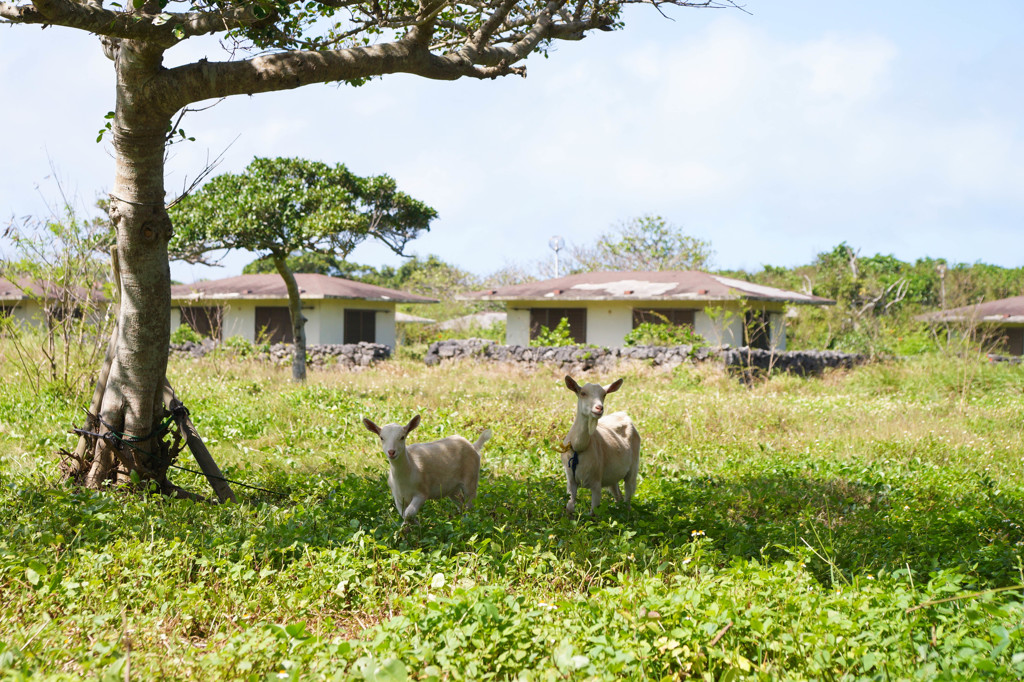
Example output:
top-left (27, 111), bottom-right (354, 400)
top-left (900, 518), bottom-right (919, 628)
top-left (170, 159), bottom-right (437, 381)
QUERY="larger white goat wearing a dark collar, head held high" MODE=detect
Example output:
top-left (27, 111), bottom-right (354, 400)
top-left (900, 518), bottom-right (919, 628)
top-left (562, 375), bottom-right (640, 515)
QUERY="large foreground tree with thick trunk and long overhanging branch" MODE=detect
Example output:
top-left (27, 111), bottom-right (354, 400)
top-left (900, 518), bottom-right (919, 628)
top-left (0, 0), bottom-right (733, 493)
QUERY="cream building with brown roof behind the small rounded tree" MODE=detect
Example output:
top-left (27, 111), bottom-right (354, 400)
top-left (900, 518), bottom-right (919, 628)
top-left (171, 273), bottom-right (437, 348)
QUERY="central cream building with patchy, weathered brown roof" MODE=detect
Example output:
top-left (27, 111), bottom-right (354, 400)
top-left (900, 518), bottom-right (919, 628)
top-left (465, 270), bottom-right (835, 350)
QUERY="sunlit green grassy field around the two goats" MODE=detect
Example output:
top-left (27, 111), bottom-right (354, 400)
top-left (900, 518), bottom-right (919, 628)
top-left (0, 357), bottom-right (1024, 680)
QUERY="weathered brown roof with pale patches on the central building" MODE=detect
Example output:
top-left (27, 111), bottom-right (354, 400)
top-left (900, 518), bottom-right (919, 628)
top-left (465, 270), bottom-right (836, 305)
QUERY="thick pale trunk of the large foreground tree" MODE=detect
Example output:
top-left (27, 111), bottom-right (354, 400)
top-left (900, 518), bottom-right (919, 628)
top-left (77, 41), bottom-right (173, 491)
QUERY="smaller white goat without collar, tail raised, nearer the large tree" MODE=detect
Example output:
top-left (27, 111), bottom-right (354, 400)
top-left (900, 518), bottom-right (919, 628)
top-left (362, 415), bottom-right (490, 522)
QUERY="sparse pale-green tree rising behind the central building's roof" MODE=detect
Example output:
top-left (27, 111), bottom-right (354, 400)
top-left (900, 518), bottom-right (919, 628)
top-left (572, 215), bottom-right (714, 272)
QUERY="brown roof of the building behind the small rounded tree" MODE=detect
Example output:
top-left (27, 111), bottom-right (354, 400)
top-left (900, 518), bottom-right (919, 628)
top-left (171, 273), bottom-right (437, 303)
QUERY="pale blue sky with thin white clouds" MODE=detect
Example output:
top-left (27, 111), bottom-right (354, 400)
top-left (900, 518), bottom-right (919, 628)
top-left (0, 0), bottom-right (1024, 283)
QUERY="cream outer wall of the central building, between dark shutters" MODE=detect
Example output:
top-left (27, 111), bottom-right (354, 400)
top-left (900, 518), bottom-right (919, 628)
top-left (505, 301), bottom-right (785, 350)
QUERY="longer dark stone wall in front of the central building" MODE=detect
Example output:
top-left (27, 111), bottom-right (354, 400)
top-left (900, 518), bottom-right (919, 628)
top-left (423, 339), bottom-right (867, 375)
